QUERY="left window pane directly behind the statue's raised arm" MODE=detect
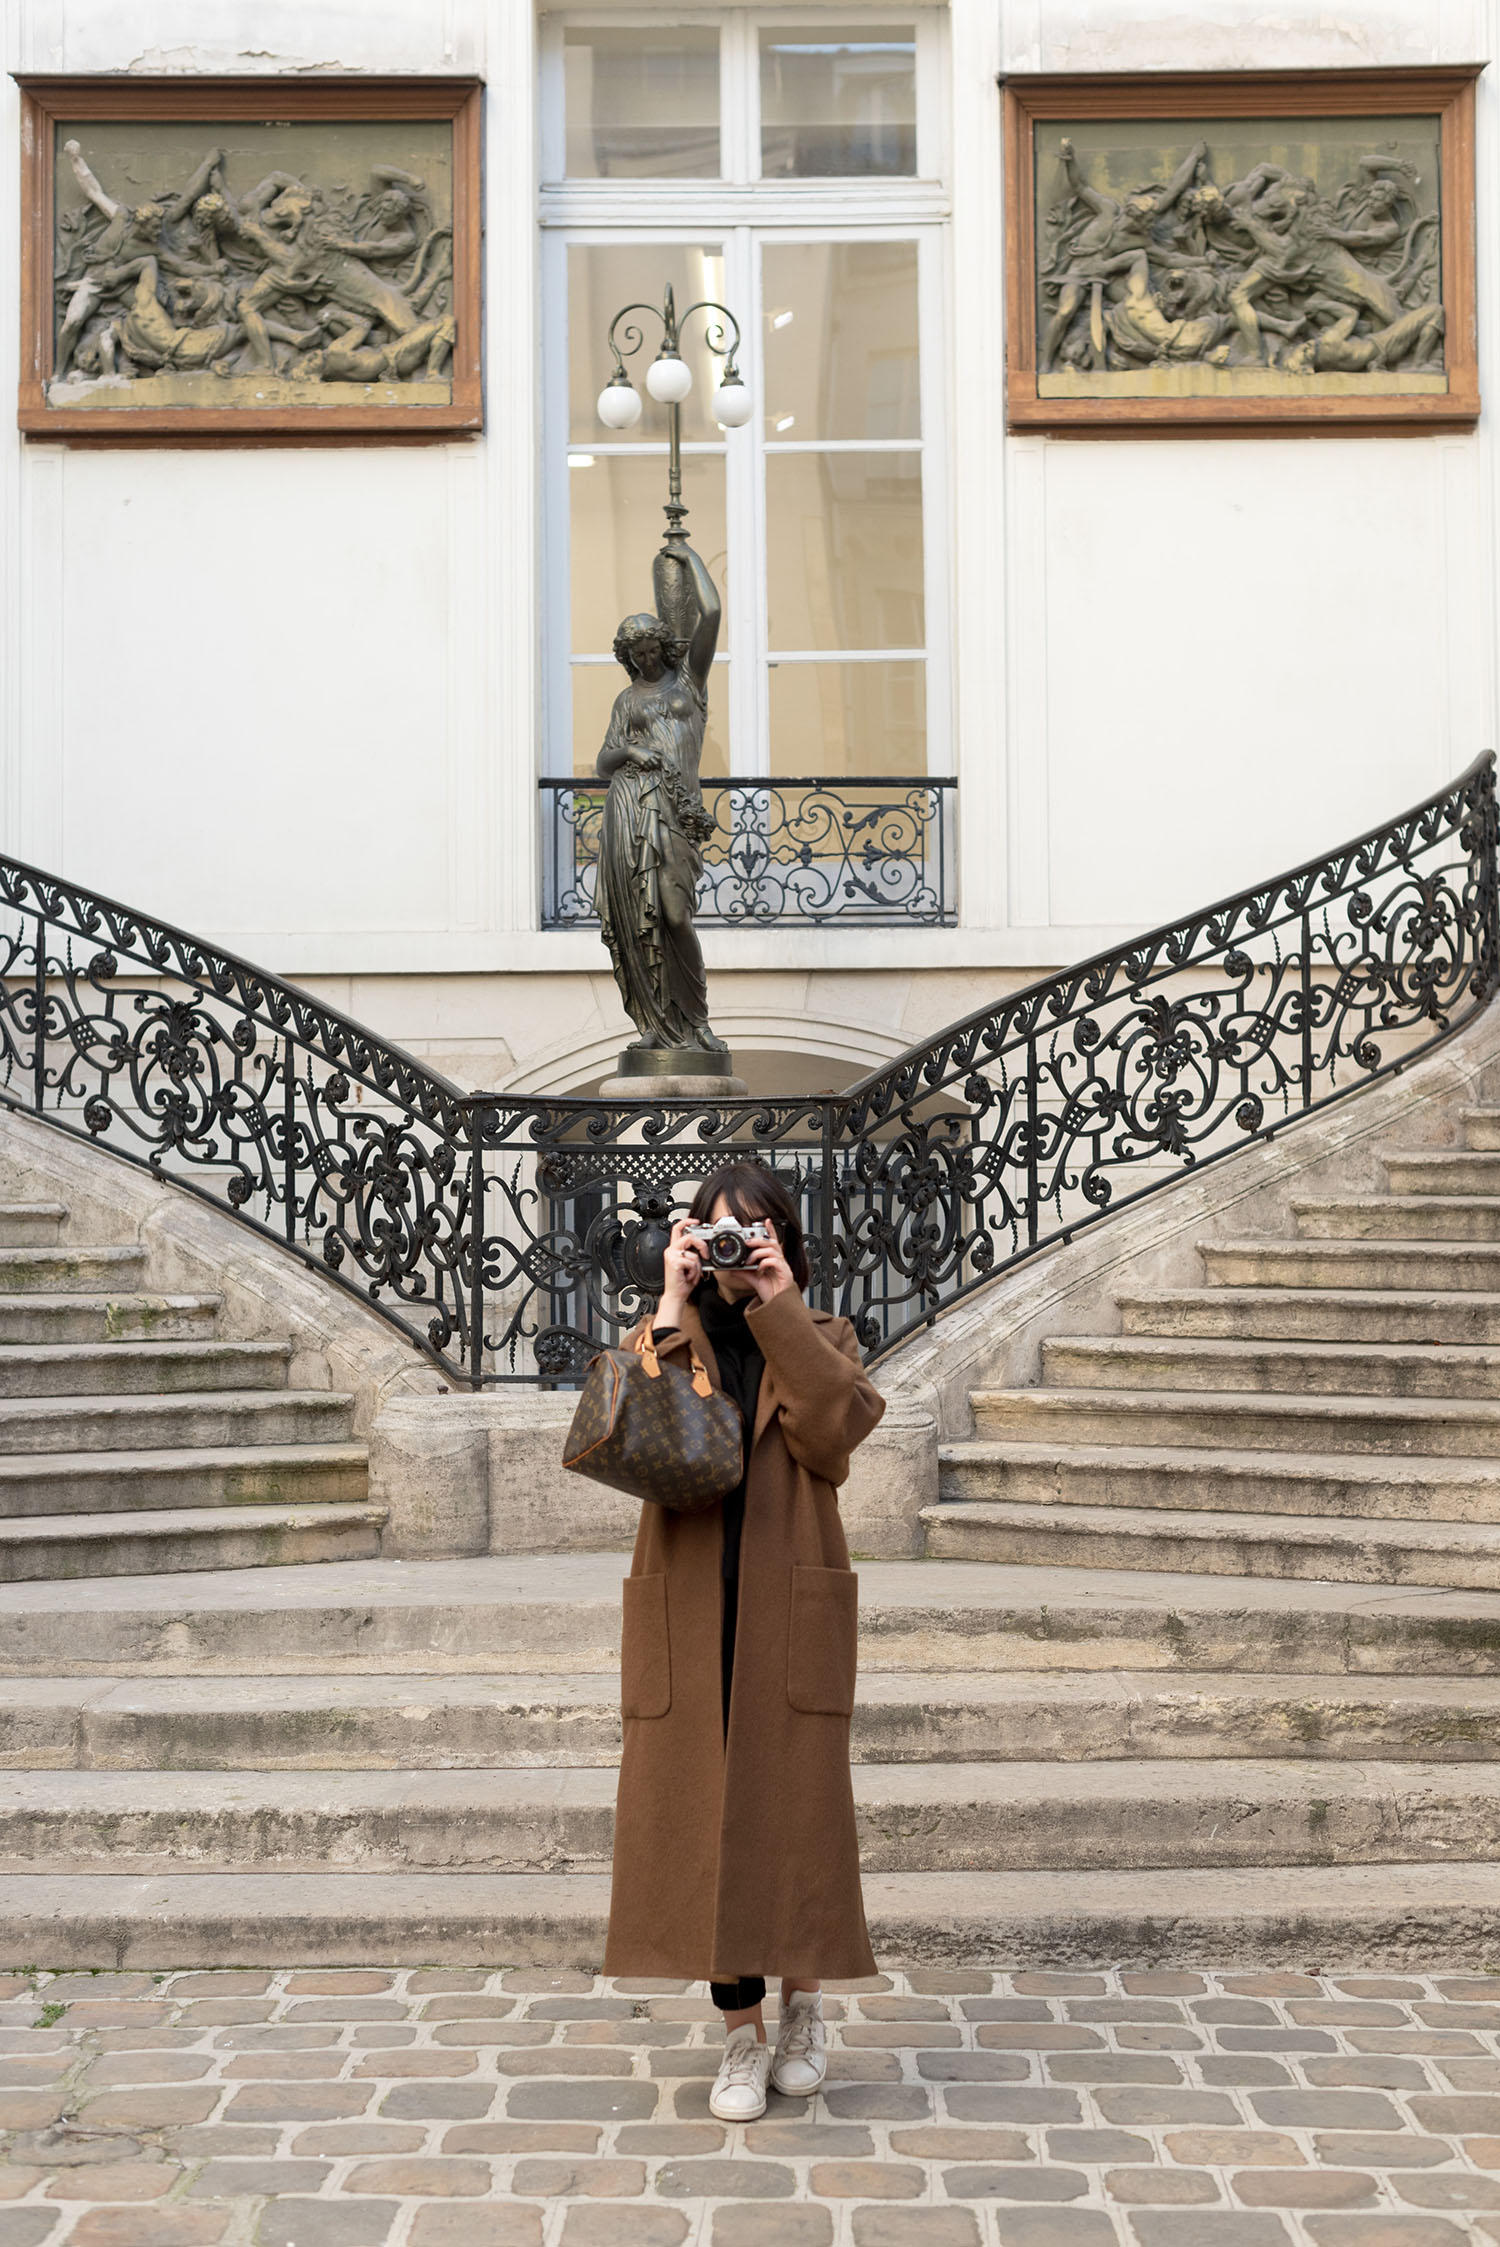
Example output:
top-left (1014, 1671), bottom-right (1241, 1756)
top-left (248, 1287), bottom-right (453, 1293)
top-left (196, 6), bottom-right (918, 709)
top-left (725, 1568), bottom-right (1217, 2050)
top-left (568, 447), bottom-right (728, 656)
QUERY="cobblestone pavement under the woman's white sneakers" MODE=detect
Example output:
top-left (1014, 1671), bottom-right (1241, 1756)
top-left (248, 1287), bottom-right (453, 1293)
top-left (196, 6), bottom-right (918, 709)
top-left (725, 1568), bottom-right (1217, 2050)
top-left (0, 1968), bottom-right (1500, 2247)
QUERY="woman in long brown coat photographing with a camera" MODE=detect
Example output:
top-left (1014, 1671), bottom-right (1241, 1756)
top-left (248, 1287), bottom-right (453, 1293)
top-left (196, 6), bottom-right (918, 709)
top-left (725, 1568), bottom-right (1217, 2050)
top-left (604, 1162), bottom-right (885, 2121)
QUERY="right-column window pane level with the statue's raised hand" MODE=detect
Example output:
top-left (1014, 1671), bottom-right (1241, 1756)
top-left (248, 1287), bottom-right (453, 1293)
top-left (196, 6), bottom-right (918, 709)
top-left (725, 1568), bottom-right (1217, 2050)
top-left (766, 452), bottom-right (927, 649)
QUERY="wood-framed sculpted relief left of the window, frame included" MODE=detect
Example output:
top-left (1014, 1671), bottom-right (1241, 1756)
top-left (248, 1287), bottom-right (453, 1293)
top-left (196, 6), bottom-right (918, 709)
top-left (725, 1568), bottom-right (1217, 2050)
top-left (16, 74), bottom-right (483, 445)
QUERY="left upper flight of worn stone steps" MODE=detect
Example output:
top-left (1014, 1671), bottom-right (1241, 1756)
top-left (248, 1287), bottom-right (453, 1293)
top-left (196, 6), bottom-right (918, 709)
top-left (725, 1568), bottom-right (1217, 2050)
top-left (0, 1200), bottom-right (384, 1584)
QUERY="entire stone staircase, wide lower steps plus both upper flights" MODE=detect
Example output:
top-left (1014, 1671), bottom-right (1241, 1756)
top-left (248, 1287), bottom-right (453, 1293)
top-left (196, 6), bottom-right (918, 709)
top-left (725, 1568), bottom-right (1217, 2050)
top-left (0, 1110), bottom-right (1500, 1968)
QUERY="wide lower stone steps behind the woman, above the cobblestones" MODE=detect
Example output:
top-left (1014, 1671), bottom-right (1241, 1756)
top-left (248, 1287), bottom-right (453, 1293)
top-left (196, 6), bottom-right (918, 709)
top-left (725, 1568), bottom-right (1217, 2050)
top-left (0, 1555), bottom-right (1500, 1966)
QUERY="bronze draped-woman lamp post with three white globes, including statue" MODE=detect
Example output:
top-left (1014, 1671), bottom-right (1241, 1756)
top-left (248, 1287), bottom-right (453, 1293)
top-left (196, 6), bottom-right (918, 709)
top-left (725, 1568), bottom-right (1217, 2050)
top-left (595, 290), bottom-right (754, 1099)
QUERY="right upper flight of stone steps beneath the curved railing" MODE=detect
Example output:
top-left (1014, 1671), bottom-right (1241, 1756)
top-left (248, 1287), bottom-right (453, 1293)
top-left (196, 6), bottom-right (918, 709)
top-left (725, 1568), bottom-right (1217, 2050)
top-left (923, 1108), bottom-right (1500, 1591)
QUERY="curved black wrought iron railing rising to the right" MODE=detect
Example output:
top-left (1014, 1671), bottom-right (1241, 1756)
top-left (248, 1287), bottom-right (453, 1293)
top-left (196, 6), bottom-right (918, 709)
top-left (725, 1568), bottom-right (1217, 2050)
top-left (821, 753), bottom-right (1500, 1355)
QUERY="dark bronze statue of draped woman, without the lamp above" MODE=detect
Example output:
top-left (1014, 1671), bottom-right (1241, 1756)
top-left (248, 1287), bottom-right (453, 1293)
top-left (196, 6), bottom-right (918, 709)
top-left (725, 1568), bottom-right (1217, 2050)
top-left (595, 528), bottom-right (732, 1079)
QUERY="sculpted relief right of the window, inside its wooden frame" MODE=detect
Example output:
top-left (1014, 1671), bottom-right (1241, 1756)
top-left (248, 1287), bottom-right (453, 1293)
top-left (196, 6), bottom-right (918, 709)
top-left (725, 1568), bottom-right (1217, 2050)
top-left (1037, 117), bottom-right (1446, 398)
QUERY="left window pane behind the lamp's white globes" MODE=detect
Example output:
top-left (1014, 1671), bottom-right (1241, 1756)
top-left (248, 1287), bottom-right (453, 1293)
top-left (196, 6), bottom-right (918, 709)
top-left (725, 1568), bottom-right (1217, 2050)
top-left (568, 243), bottom-right (723, 445)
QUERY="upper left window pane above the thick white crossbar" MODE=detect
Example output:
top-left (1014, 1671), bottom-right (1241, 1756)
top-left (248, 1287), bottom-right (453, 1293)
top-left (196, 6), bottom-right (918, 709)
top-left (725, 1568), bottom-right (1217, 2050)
top-left (564, 25), bottom-right (719, 180)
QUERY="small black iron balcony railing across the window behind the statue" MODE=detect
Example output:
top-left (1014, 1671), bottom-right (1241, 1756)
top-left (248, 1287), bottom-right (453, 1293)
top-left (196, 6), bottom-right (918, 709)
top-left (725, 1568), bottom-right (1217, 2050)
top-left (541, 777), bottom-right (957, 928)
